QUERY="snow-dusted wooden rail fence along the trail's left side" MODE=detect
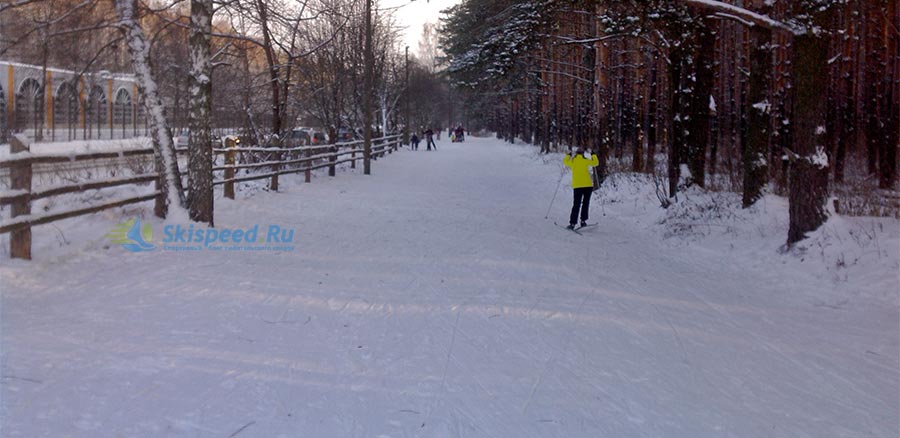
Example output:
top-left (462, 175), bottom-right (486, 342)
top-left (0, 135), bottom-right (401, 260)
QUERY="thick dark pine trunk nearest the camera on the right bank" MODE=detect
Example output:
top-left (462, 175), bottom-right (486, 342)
top-left (787, 17), bottom-right (831, 245)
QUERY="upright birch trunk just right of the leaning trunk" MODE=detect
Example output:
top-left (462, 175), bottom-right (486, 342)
top-left (188, 0), bottom-right (213, 226)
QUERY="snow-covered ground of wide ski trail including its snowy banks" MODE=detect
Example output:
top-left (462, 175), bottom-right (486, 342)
top-left (0, 137), bottom-right (900, 438)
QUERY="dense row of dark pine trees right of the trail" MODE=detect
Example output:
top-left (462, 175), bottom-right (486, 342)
top-left (460, 0), bottom-right (900, 243)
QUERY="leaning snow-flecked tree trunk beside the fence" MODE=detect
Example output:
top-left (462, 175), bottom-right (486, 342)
top-left (115, 0), bottom-right (185, 217)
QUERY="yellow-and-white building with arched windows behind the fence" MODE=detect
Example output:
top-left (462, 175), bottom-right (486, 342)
top-left (0, 61), bottom-right (148, 143)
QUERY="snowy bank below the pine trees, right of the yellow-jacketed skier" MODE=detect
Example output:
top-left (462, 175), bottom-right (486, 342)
top-left (595, 169), bottom-right (900, 306)
